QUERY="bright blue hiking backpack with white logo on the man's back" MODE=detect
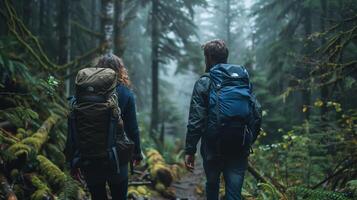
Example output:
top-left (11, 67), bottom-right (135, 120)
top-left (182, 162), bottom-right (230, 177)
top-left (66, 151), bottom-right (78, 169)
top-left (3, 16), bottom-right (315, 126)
top-left (204, 64), bottom-right (262, 156)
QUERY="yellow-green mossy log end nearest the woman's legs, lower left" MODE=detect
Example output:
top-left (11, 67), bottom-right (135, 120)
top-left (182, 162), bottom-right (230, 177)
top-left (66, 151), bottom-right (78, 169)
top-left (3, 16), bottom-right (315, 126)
top-left (37, 155), bottom-right (66, 188)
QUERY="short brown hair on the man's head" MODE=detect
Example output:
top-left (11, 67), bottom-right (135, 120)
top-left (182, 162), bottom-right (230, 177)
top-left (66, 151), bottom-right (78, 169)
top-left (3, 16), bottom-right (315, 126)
top-left (202, 39), bottom-right (229, 63)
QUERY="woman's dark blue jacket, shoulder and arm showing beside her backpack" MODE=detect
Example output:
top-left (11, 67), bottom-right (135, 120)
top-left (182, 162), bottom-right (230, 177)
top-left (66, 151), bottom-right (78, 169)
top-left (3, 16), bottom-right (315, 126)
top-left (116, 84), bottom-right (142, 160)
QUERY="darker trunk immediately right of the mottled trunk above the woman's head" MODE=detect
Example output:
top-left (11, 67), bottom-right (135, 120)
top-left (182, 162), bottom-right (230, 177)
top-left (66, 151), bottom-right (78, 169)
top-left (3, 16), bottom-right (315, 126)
top-left (114, 0), bottom-right (125, 57)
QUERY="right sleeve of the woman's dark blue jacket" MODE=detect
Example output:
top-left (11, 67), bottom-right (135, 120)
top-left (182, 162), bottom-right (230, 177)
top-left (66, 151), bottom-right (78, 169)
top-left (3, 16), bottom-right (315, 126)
top-left (123, 94), bottom-right (142, 160)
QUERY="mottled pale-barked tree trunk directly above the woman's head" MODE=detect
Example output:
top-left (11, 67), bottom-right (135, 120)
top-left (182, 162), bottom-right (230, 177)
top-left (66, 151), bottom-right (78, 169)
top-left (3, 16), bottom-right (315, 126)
top-left (101, 0), bottom-right (114, 53)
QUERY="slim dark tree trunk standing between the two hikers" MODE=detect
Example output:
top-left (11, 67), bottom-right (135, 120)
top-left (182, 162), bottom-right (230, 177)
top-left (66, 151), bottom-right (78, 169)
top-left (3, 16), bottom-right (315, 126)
top-left (150, 0), bottom-right (159, 139)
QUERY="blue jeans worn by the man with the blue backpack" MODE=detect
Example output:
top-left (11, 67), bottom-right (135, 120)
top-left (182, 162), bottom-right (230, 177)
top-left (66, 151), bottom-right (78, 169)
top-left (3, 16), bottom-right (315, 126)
top-left (203, 157), bottom-right (248, 200)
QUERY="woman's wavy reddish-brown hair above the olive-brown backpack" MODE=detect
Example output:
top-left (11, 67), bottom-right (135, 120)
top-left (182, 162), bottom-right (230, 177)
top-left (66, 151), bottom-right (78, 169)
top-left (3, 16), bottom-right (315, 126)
top-left (96, 54), bottom-right (131, 88)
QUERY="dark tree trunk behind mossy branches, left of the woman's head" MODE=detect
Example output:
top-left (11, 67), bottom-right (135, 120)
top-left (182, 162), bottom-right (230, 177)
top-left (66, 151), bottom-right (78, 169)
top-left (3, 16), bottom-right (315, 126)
top-left (58, 0), bottom-right (71, 96)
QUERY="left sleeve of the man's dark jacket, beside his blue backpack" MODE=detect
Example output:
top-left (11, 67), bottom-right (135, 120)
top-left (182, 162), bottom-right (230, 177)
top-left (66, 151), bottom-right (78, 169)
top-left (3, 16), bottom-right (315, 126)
top-left (185, 77), bottom-right (209, 155)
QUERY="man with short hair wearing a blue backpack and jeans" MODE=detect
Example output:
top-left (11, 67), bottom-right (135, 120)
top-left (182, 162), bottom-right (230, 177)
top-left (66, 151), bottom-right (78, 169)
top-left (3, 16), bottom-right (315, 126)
top-left (185, 40), bottom-right (261, 200)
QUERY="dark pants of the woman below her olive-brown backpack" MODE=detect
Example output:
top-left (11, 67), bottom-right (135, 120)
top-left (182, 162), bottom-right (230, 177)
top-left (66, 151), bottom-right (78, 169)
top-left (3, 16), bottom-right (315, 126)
top-left (83, 162), bottom-right (128, 200)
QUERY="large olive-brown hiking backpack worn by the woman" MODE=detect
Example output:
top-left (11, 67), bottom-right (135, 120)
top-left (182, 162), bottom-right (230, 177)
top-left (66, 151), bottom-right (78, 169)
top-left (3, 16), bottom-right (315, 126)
top-left (66, 68), bottom-right (134, 173)
